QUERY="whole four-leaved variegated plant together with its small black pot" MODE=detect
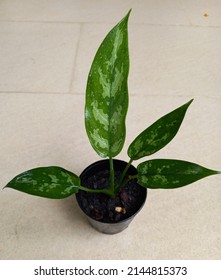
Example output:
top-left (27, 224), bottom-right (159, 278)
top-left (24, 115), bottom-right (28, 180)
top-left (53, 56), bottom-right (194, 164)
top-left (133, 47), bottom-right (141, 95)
top-left (3, 11), bottom-right (221, 233)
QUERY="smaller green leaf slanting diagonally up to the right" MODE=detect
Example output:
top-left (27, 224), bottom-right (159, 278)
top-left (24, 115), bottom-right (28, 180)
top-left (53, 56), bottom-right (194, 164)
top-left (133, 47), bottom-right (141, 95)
top-left (128, 99), bottom-right (193, 160)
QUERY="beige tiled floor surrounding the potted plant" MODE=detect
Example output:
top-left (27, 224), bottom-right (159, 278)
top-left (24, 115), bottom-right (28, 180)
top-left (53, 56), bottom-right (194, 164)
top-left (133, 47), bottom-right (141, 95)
top-left (0, 0), bottom-right (221, 259)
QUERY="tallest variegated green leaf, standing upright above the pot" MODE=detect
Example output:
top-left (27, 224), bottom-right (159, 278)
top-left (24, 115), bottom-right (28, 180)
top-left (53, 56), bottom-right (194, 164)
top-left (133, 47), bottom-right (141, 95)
top-left (85, 9), bottom-right (130, 157)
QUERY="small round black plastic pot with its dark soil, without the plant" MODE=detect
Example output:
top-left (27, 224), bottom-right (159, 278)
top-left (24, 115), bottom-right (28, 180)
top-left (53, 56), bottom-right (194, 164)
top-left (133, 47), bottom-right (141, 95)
top-left (76, 159), bottom-right (147, 234)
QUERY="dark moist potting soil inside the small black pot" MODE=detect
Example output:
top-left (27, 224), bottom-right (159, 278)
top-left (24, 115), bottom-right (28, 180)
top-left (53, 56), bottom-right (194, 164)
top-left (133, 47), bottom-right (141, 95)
top-left (77, 170), bottom-right (145, 223)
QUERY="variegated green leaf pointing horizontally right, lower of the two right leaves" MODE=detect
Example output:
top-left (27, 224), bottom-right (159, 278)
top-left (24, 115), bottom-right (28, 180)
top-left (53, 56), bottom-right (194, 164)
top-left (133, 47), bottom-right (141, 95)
top-left (137, 159), bottom-right (220, 189)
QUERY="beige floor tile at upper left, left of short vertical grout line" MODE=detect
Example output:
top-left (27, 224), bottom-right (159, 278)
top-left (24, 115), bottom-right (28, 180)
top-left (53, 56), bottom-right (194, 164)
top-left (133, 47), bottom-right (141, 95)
top-left (0, 22), bottom-right (79, 92)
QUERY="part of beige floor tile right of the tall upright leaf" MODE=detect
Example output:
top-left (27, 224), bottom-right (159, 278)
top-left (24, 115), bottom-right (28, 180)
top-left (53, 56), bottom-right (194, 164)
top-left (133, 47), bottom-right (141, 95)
top-left (130, 26), bottom-right (221, 96)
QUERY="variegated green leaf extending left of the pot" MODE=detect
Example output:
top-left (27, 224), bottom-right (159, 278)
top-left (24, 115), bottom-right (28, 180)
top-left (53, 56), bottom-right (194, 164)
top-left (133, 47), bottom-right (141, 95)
top-left (5, 166), bottom-right (80, 198)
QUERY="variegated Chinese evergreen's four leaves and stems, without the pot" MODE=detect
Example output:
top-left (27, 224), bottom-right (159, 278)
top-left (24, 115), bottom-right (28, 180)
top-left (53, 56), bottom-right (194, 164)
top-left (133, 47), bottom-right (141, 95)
top-left (3, 11), bottom-right (221, 199)
